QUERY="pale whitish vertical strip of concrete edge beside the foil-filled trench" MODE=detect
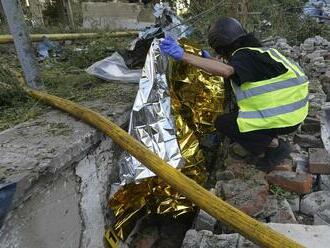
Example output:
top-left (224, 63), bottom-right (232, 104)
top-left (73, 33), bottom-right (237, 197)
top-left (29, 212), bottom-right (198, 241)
top-left (76, 138), bottom-right (119, 248)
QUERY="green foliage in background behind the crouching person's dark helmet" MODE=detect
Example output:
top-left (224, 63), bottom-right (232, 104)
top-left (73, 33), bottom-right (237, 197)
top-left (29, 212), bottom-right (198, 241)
top-left (182, 0), bottom-right (330, 45)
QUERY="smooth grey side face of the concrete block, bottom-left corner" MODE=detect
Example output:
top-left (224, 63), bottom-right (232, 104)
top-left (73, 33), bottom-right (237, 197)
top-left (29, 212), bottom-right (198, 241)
top-left (0, 170), bottom-right (83, 248)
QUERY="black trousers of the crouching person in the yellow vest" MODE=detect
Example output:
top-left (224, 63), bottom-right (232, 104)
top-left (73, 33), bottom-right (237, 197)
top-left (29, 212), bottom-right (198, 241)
top-left (214, 112), bottom-right (300, 155)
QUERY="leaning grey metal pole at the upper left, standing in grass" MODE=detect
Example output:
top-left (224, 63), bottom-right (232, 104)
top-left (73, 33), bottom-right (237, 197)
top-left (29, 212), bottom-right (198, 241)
top-left (1, 0), bottom-right (43, 89)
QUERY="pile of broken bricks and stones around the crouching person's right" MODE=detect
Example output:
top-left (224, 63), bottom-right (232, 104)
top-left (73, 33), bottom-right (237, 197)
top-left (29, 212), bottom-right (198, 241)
top-left (182, 36), bottom-right (330, 248)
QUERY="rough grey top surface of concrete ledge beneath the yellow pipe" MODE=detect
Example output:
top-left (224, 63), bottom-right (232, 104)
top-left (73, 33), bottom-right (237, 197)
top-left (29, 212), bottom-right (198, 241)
top-left (0, 100), bottom-right (132, 207)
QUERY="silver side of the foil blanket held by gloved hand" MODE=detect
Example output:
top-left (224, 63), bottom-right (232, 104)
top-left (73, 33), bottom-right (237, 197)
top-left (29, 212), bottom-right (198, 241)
top-left (120, 39), bottom-right (184, 185)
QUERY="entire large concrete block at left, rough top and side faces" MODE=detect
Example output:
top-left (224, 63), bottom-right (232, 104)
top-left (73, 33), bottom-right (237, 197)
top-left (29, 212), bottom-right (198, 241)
top-left (0, 91), bottom-right (134, 248)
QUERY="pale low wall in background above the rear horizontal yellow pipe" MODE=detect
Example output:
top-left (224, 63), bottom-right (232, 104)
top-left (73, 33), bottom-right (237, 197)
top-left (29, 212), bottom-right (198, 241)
top-left (82, 2), bottom-right (155, 30)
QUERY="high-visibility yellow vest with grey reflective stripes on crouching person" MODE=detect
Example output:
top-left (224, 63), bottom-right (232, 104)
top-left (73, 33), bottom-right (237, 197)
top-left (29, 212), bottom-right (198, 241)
top-left (232, 47), bottom-right (309, 132)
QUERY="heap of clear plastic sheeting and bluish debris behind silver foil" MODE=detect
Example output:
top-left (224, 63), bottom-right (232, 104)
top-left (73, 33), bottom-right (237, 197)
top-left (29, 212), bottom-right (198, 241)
top-left (86, 3), bottom-right (189, 83)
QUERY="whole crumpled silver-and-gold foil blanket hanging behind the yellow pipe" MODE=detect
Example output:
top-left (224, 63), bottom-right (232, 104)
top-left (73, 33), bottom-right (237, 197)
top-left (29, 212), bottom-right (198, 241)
top-left (109, 40), bottom-right (224, 240)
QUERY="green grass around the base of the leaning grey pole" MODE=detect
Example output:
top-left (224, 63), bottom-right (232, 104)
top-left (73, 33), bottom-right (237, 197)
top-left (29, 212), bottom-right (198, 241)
top-left (0, 36), bottom-right (135, 131)
